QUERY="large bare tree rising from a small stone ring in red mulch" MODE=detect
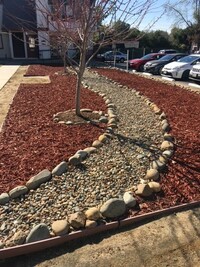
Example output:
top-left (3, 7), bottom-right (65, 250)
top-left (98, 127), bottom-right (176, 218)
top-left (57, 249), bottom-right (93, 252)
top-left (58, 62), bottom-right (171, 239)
top-left (4, 0), bottom-right (164, 116)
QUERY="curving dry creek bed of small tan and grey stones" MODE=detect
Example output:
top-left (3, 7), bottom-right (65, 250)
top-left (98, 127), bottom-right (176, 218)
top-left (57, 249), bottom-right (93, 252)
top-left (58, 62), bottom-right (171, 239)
top-left (0, 69), bottom-right (173, 248)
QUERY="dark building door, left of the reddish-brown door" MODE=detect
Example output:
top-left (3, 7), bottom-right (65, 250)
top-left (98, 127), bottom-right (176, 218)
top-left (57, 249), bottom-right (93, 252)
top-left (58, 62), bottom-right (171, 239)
top-left (12, 32), bottom-right (25, 58)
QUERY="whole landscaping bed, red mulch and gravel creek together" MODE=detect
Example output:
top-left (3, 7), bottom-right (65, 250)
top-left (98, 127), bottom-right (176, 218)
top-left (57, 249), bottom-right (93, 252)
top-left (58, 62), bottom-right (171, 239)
top-left (0, 66), bottom-right (200, 255)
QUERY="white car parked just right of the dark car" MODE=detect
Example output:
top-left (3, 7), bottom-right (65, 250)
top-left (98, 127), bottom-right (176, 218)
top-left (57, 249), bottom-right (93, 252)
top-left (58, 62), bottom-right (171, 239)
top-left (161, 54), bottom-right (200, 80)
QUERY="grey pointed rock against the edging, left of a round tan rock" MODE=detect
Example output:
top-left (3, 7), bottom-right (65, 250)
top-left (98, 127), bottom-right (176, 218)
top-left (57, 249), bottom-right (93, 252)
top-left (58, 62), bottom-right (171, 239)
top-left (26, 223), bottom-right (50, 243)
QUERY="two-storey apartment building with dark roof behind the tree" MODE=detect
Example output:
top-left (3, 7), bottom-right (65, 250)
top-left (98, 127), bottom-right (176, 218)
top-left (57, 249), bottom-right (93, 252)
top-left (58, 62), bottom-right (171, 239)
top-left (0, 0), bottom-right (75, 59)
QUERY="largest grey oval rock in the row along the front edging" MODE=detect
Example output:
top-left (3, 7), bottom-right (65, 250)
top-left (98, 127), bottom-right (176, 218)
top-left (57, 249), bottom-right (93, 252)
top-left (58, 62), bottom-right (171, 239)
top-left (100, 198), bottom-right (126, 218)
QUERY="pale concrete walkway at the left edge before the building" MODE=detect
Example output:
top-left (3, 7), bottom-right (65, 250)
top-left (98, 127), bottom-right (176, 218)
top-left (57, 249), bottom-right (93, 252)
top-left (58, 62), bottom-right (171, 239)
top-left (0, 65), bottom-right (20, 90)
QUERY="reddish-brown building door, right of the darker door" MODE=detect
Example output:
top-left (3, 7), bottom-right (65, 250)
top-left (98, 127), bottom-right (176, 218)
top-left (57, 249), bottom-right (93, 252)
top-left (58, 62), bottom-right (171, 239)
top-left (26, 33), bottom-right (39, 58)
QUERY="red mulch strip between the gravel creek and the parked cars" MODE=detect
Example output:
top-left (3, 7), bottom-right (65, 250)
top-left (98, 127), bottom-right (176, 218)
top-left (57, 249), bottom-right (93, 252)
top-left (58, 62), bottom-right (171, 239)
top-left (96, 69), bottom-right (200, 212)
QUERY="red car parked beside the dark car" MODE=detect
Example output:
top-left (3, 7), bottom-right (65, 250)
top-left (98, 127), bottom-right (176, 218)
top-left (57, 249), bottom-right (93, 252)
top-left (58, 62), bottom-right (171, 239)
top-left (129, 53), bottom-right (165, 71)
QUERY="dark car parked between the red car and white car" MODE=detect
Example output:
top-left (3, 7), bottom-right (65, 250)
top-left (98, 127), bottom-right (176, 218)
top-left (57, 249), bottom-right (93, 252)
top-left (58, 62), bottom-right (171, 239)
top-left (144, 53), bottom-right (187, 74)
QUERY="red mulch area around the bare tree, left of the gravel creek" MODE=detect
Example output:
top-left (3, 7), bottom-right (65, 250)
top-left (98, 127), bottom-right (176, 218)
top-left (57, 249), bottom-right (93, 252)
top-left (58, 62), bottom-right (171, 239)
top-left (0, 66), bottom-right (106, 193)
